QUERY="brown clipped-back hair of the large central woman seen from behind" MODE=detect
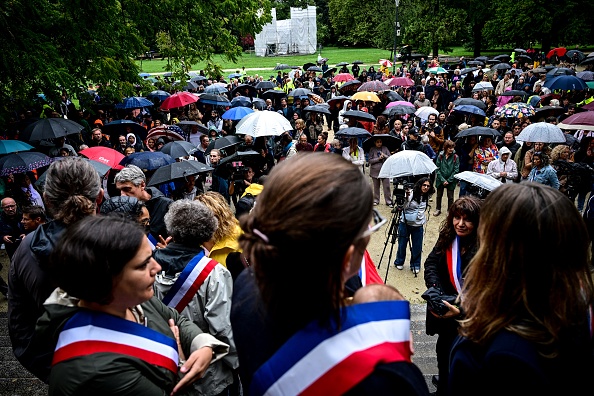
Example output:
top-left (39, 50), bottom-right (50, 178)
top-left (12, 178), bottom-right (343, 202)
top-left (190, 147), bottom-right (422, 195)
top-left (240, 153), bottom-right (373, 331)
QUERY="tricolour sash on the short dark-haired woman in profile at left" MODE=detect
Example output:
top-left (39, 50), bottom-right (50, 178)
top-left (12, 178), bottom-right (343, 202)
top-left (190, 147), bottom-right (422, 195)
top-left (52, 310), bottom-right (179, 373)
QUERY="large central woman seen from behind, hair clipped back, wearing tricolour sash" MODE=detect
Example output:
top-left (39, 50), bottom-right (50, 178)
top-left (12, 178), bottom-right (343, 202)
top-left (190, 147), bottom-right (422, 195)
top-left (231, 153), bottom-right (428, 396)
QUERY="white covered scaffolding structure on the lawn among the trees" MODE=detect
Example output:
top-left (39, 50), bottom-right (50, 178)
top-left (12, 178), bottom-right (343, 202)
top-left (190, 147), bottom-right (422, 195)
top-left (254, 6), bottom-right (318, 56)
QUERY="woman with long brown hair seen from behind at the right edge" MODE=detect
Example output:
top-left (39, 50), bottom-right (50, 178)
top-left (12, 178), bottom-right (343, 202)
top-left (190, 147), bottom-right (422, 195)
top-left (449, 183), bottom-right (594, 396)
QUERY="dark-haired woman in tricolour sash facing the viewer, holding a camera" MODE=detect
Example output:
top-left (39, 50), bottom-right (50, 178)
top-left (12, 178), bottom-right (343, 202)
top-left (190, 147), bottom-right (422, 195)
top-left (424, 195), bottom-right (481, 395)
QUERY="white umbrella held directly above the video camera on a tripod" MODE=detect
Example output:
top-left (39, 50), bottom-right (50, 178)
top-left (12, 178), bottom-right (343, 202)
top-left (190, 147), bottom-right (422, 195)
top-left (378, 150), bottom-right (437, 179)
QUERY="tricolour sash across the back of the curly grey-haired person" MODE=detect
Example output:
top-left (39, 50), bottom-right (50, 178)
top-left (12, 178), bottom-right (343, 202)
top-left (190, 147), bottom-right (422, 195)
top-left (163, 250), bottom-right (218, 312)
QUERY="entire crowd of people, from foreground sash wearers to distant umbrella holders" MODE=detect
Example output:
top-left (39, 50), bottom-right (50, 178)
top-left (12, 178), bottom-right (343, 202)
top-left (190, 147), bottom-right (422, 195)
top-left (0, 50), bottom-right (594, 395)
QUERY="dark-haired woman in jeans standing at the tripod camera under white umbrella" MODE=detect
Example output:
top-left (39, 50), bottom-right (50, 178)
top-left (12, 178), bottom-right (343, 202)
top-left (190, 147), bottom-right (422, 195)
top-left (394, 177), bottom-right (435, 276)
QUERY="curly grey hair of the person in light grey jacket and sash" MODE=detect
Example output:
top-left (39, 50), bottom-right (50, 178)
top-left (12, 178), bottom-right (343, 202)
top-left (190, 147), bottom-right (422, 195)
top-left (165, 199), bottom-right (218, 246)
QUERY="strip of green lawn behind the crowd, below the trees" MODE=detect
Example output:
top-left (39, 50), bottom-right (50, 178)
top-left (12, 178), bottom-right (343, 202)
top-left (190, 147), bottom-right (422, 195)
top-left (136, 47), bottom-right (390, 73)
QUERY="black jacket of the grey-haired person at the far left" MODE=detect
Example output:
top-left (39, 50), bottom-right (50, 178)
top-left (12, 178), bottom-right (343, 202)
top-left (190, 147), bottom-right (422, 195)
top-left (8, 221), bottom-right (66, 381)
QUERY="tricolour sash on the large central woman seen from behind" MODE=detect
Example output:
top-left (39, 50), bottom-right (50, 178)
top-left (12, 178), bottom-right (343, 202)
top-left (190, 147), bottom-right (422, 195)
top-left (250, 301), bottom-right (411, 396)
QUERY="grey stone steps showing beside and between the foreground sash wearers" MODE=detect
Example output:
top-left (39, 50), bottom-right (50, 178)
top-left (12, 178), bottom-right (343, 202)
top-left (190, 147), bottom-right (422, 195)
top-left (0, 310), bottom-right (437, 396)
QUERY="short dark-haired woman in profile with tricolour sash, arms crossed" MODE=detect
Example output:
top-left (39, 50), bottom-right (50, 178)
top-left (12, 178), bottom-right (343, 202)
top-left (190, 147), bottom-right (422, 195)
top-left (34, 216), bottom-right (228, 396)
